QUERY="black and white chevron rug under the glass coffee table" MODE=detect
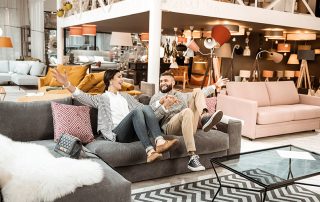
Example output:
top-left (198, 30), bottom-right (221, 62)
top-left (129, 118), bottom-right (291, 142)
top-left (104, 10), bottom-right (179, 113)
top-left (132, 170), bottom-right (320, 202)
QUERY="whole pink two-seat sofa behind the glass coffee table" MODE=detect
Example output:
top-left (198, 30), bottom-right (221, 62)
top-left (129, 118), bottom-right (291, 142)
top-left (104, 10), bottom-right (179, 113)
top-left (217, 81), bottom-right (320, 139)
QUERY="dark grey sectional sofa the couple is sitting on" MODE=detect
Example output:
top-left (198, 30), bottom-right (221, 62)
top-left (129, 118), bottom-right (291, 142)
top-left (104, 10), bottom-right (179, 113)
top-left (0, 98), bottom-right (241, 202)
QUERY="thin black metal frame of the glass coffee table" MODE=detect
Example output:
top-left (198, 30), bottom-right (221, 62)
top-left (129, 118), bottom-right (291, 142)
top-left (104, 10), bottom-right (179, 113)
top-left (210, 145), bottom-right (320, 202)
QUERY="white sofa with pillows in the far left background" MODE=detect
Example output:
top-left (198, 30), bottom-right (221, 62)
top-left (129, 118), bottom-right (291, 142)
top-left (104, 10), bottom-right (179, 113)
top-left (0, 60), bottom-right (47, 85)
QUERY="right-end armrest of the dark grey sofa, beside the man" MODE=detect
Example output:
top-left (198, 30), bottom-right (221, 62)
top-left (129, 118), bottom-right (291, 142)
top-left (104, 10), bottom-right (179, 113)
top-left (217, 119), bottom-right (242, 155)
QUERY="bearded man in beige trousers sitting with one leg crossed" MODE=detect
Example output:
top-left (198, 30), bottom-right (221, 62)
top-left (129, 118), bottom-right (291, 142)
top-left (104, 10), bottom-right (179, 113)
top-left (150, 72), bottom-right (227, 171)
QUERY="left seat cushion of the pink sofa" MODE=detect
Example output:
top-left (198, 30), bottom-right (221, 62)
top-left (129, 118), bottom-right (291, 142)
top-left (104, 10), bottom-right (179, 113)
top-left (257, 105), bottom-right (294, 124)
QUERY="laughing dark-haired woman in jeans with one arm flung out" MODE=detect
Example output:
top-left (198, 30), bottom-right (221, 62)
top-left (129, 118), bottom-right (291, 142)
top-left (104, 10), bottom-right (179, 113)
top-left (53, 69), bottom-right (178, 163)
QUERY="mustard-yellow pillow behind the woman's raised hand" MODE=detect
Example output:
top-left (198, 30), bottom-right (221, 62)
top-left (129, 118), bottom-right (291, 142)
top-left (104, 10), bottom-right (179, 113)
top-left (49, 65), bottom-right (88, 86)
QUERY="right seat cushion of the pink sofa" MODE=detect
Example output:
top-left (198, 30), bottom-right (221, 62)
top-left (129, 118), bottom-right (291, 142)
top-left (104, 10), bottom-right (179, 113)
top-left (282, 104), bottom-right (320, 120)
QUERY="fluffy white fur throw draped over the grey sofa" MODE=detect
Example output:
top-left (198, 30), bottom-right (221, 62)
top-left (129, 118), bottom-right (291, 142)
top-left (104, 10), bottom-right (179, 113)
top-left (0, 134), bottom-right (103, 202)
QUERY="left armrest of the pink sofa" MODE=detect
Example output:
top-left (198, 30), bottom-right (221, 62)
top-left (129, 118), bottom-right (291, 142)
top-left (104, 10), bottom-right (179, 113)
top-left (217, 94), bottom-right (258, 139)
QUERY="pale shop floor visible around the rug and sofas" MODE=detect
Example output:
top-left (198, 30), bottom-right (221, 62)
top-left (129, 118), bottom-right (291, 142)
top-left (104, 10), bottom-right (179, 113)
top-left (4, 86), bottom-right (320, 193)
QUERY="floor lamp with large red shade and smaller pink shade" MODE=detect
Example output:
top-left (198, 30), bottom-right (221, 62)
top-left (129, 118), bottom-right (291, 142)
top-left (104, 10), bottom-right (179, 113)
top-left (187, 25), bottom-right (231, 89)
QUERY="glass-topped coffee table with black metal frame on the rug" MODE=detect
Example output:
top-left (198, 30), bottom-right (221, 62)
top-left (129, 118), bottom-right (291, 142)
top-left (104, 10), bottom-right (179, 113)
top-left (210, 145), bottom-right (320, 201)
